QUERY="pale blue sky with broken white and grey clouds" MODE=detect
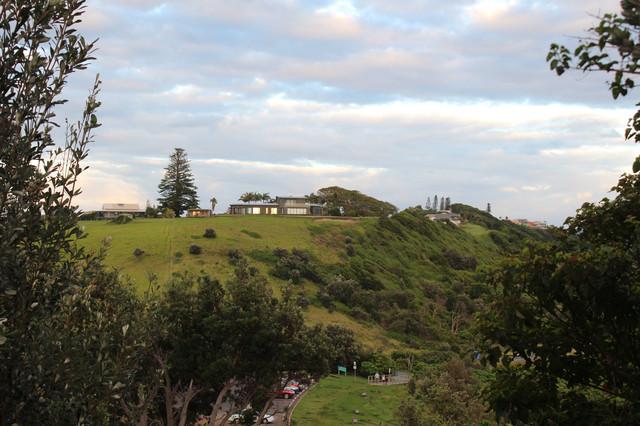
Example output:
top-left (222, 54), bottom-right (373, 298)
top-left (62, 0), bottom-right (640, 224)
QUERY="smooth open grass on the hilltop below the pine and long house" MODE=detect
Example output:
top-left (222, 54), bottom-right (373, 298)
top-left (80, 216), bottom-right (358, 290)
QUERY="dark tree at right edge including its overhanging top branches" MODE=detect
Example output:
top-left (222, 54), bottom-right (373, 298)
top-left (480, 5), bottom-right (640, 425)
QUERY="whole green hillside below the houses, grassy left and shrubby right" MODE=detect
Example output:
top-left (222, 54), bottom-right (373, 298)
top-left (83, 205), bottom-right (547, 356)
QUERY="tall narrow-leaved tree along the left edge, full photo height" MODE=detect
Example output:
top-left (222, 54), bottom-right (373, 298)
top-left (0, 0), bottom-right (158, 425)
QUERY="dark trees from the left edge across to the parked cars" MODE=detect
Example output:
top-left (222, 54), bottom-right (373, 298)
top-left (0, 5), bottom-right (358, 425)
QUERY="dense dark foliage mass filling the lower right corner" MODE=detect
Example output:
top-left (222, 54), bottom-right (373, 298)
top-left (481, 166), bottom-right (640, 424)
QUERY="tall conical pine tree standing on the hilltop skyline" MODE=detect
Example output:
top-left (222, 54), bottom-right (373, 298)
top-left (158, 148), bottom-right (198, 216)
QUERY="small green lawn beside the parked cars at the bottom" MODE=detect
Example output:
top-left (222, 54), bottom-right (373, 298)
top-left (293, 375), bottom-right (407, 426)
